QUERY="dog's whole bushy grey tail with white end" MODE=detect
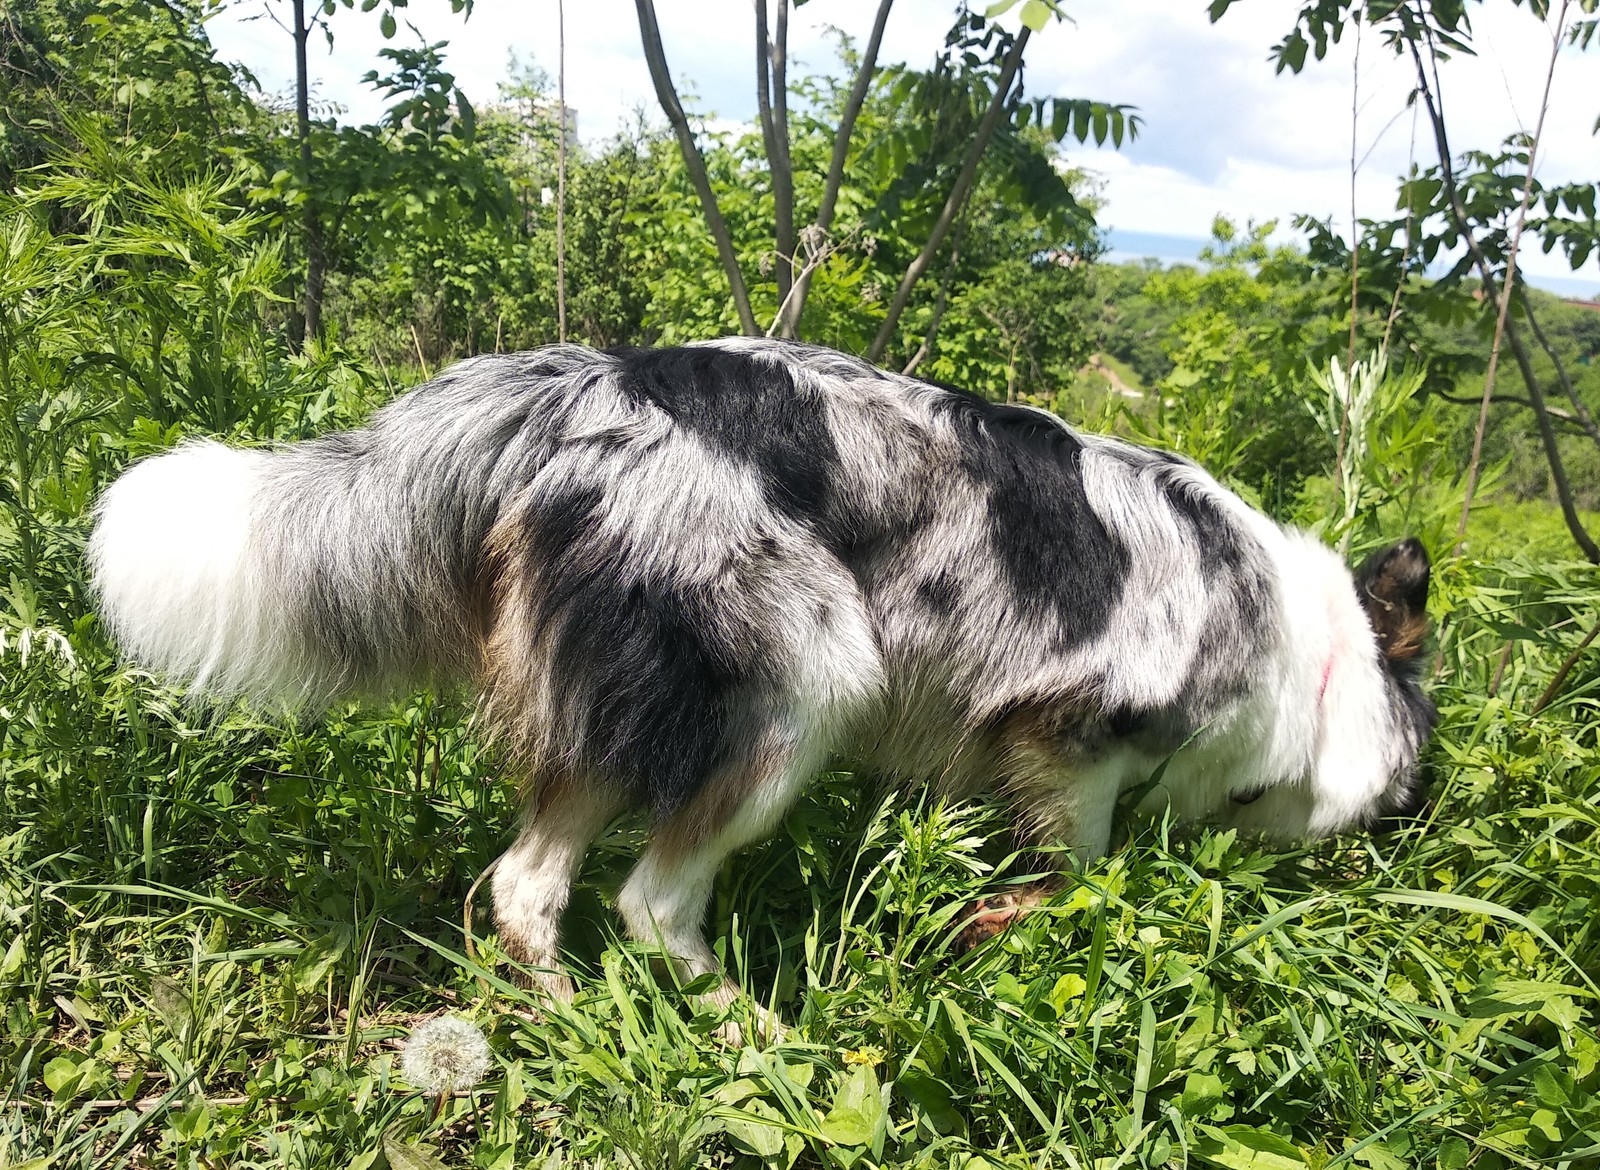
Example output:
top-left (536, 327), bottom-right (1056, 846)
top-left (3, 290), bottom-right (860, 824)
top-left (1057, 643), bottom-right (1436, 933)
top-left (88, 363), bottom-right (547, 707)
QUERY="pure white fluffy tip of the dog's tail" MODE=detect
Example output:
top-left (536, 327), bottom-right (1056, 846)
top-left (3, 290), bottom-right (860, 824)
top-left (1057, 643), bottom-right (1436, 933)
top-left (88, 442), bottom-right (314, 703)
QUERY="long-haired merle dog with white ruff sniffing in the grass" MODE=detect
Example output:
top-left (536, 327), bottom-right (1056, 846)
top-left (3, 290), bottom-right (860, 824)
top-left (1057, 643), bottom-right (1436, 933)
top-left (90, 339), bottom-right (1434, 994)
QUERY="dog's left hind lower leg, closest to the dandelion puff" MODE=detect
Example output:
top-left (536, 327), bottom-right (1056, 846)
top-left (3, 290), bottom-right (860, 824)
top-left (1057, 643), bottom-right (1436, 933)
top-left (494, 779), bottom-right (624, 1000)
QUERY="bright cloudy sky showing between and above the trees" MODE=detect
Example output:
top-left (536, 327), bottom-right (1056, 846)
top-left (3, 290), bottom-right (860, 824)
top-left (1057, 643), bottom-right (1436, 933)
top-left (208, 0), bottom-right (1600, 298)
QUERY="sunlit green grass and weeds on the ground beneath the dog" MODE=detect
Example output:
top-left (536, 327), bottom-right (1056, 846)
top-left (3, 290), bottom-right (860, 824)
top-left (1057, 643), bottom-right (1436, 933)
top-left (0, 534), bottom-right (1600, 1170)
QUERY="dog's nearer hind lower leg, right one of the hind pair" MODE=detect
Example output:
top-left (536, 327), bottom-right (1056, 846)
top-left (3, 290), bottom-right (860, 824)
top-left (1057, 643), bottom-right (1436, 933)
top-left (618, 733), bottom-right (829, 1030)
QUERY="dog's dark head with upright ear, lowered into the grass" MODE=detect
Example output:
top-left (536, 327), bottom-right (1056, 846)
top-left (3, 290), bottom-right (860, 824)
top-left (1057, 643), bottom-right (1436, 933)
top-left (1355, 538), bottom-right (1438, 827)
